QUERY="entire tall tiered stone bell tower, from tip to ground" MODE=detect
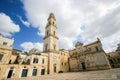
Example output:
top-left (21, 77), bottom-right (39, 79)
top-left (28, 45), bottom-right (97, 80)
top-left (43, 13), bottom-right (60, 74)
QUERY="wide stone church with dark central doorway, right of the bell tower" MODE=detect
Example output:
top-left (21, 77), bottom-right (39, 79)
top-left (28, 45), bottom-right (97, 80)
top-left (69, 39), bottom-right (111, 71)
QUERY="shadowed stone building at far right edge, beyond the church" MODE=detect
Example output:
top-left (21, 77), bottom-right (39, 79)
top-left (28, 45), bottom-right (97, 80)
top-left (107, 44), bottom-right (120, 68)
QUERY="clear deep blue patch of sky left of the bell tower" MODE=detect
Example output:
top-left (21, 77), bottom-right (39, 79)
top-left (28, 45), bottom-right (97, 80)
top-left (0, 0), bottom-right (43, 50)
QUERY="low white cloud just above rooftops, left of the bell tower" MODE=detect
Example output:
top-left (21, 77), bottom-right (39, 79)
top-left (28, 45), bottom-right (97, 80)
top-left (20, 42), bottom-right (43, 51)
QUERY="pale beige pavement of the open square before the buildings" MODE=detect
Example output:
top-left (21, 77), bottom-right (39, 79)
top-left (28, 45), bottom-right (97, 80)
top-left (9, 68), bottom-right (120, 80)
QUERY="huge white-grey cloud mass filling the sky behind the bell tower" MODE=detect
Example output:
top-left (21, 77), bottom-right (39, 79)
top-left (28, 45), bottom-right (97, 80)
top-left (23, 0), bottom-right (120, 50)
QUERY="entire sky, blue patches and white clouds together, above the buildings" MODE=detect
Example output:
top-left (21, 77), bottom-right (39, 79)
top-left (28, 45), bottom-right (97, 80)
top-left (0, 0), bottom-right (120, 52)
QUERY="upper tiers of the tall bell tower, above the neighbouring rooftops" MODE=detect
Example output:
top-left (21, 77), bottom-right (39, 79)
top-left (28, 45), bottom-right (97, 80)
top-left (43, 13), bottom-right (59, 52)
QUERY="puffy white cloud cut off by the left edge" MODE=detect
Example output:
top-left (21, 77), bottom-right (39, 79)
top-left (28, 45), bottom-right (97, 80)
top-left (0, 13), bottom-right (20, 37)
